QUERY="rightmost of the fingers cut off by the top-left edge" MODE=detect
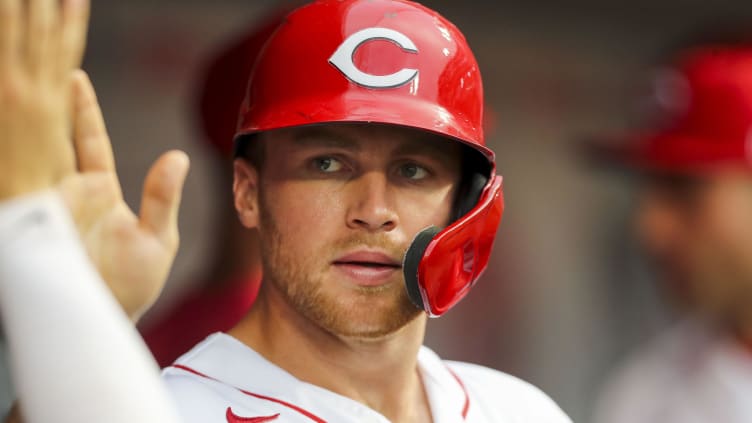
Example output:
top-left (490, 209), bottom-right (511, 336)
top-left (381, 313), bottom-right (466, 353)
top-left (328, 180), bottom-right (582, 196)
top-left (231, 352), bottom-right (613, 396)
top-left (59, 0), bottom-right (90, 73)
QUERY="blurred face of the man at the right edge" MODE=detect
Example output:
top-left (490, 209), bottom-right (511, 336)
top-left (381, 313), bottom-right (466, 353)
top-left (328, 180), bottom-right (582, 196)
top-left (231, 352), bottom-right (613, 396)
top-left (637, 170), bottom-right (752, 323)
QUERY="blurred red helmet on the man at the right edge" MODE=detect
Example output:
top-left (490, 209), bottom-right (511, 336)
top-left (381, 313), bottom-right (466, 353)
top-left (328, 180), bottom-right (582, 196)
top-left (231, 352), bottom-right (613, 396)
top-left (608, 44), bottom-right (752, 172)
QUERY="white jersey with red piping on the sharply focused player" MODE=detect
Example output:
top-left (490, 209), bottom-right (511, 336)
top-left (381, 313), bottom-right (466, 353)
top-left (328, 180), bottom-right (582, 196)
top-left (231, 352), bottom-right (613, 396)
top-left (163, 333), bottom-right (571, 423)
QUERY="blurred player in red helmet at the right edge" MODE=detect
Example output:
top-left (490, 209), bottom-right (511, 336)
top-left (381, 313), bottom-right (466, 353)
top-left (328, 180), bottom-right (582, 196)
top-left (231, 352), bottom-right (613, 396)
top-left (594, 43), bottom-right (752, 423)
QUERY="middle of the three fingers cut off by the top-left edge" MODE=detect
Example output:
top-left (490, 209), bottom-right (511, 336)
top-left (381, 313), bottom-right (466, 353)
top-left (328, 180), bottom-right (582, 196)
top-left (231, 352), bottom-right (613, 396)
top-left (25, 0), bottom-right (58, 75)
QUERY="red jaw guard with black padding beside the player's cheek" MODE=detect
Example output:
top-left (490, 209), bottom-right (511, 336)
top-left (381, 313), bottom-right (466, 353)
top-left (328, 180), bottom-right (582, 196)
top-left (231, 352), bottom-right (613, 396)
top-left (403, 175), bottom-right (504, 317)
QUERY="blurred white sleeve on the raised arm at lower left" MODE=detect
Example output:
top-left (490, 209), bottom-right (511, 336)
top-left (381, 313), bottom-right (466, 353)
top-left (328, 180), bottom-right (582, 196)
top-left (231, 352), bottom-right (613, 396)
top-left (0, 192), bottom-right (178, 423)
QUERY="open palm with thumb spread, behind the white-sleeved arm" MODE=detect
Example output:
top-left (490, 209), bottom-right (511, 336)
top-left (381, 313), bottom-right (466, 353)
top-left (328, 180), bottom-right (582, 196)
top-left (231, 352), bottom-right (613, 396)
top-left (59, 71), bottom-right (188, 319)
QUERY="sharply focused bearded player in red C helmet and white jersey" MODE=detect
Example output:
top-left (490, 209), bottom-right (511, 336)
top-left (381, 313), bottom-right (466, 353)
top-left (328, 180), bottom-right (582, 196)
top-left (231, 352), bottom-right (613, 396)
top-left (164, 0), bottom-right (569, 423)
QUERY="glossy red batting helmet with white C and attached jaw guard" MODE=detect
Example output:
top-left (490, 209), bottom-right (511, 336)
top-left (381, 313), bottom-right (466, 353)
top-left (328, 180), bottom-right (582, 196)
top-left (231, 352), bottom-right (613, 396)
top-left (236, 0), bottom-right (504, 316)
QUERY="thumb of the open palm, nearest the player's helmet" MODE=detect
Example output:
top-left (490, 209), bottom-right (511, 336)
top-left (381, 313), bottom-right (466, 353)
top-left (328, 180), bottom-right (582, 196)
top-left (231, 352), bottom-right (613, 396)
top-left (139, 150), bottom-right (189, 247)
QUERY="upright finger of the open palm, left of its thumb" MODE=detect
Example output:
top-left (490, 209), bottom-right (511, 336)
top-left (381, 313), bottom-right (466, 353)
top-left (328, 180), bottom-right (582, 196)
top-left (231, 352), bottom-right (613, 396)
top-left (73, 69), bottom-right (115, 172)
